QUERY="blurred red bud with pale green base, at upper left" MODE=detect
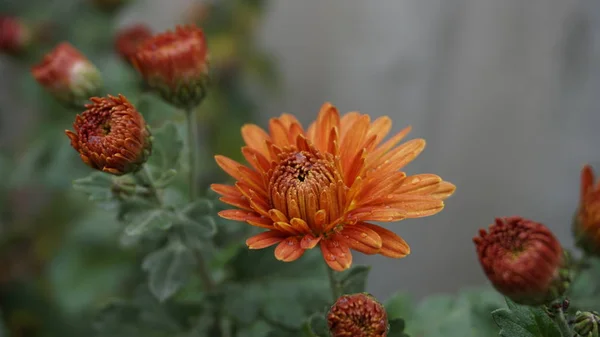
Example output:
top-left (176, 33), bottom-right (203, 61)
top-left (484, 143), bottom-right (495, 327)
top-left (31, 42), bottom-right (102, 108)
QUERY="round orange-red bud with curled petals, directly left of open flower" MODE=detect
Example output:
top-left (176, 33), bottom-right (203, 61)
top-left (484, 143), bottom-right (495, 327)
top-left (65, 95), bottom-right (152, 175)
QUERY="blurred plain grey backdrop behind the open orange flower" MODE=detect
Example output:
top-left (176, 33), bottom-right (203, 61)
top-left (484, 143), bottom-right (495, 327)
top-left (5, 0), bottom-right (600, 297)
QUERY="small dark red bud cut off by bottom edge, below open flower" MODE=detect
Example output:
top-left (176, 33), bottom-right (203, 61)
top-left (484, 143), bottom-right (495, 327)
top-left (327, 293), bottom-right (389, 337)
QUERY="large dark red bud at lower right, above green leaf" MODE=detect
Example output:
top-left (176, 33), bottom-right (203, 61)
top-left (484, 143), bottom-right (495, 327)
top-left (473, 217), bottom-right (570, 305)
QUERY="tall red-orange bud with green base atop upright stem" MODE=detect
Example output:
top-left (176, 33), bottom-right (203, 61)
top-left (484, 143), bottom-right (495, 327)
top-left (132, 26), bottom-right (208, 109)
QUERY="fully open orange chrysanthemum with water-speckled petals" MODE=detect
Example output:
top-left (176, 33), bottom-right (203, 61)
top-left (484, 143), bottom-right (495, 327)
top-left (212, 103), bottom-right (455, 271)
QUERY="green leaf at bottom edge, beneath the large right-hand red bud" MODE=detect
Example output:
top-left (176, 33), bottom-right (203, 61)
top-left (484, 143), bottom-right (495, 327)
top-left (492, 298), bottom-right (561, 337)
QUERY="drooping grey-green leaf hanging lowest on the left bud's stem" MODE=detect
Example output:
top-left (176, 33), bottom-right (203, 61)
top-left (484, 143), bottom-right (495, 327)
top-left (142, 239), bottom-right (196, 302)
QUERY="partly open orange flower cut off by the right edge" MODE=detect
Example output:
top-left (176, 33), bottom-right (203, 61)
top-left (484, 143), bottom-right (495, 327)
top-left (573, 165), bottom-right (600, 256)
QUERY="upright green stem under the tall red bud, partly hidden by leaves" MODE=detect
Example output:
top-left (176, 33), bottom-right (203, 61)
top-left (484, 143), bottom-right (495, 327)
top-left (185, 109), bottom-right (215, 292)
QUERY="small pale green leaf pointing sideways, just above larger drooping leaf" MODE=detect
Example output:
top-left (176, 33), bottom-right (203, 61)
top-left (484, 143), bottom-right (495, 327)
top-left (125, 208), bottom-right (174, 236)
